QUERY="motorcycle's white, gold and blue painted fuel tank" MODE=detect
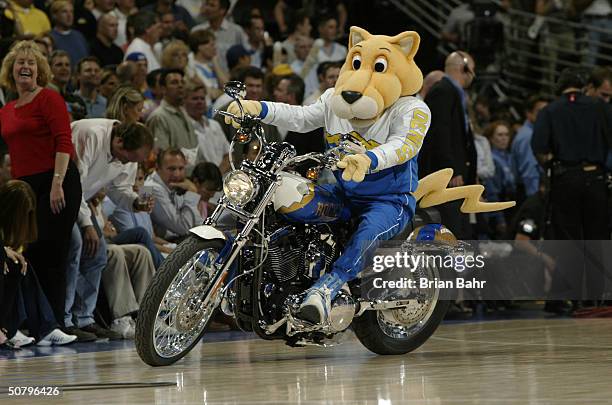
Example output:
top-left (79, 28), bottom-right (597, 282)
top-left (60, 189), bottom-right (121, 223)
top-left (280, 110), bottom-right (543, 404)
top-left (272, 172), bottom-right (350, 224)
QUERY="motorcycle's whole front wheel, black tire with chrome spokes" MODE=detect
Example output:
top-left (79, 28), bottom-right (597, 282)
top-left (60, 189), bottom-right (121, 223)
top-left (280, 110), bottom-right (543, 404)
top-left (135, 236), bottom-right (223, 366)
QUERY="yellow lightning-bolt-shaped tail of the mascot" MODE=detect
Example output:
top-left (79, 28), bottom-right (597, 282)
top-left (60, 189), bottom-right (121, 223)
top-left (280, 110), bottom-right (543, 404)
top-left (412, 169), bottom-right (516, 214)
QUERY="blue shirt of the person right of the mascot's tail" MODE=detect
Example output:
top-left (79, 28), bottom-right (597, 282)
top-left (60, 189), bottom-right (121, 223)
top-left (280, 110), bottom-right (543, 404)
top-left (511, 121), bottom-right (541, 197)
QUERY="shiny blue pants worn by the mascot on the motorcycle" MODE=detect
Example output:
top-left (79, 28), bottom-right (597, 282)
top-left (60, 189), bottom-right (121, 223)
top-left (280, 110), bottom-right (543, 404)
top-left (322, 184), bottom-right (416, 282)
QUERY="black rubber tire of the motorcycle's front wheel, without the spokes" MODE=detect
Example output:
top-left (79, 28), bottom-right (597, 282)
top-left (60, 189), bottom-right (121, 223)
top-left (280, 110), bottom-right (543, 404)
top-left (135, 235), bottom-right (224, 366)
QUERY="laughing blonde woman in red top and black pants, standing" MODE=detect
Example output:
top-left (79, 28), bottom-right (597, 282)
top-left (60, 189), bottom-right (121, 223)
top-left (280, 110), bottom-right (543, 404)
top-left (0, 41), bottom-right (82, 322)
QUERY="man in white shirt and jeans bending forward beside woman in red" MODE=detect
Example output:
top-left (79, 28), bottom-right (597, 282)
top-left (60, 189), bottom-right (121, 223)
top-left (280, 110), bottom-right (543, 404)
top-left (64, 119), bottom-right (153, 339)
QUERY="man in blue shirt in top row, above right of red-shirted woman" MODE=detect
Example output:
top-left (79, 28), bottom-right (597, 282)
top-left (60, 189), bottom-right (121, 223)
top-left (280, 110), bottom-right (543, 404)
top-left (50, 0), bottom-right (89, 65)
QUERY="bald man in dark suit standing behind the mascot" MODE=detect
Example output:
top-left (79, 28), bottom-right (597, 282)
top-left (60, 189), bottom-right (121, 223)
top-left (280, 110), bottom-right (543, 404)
top-left (419, 51), bottom-right (477, 239)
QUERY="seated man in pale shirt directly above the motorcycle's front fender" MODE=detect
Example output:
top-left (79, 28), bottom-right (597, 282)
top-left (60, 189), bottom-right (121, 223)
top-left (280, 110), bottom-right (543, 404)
top-left (145, 148), bottom-right (202, 241)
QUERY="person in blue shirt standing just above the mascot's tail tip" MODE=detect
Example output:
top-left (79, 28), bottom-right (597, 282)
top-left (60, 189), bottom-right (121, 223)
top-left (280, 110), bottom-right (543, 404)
top-left (511, 95), bottom-right (548, 204)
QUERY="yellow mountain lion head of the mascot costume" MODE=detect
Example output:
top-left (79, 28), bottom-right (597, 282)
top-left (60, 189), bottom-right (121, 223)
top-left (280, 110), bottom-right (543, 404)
top-left (331, 27), bottom-right (423, 127)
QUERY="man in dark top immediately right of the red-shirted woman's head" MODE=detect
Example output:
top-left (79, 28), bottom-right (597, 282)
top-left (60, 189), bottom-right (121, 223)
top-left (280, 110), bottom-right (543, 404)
top-left (49, 50), bottom-right (87, 121)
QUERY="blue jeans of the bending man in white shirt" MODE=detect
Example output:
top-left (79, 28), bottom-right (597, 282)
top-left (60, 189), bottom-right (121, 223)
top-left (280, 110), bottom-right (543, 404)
top-left (64, 224), bottom-right (107, 328)
